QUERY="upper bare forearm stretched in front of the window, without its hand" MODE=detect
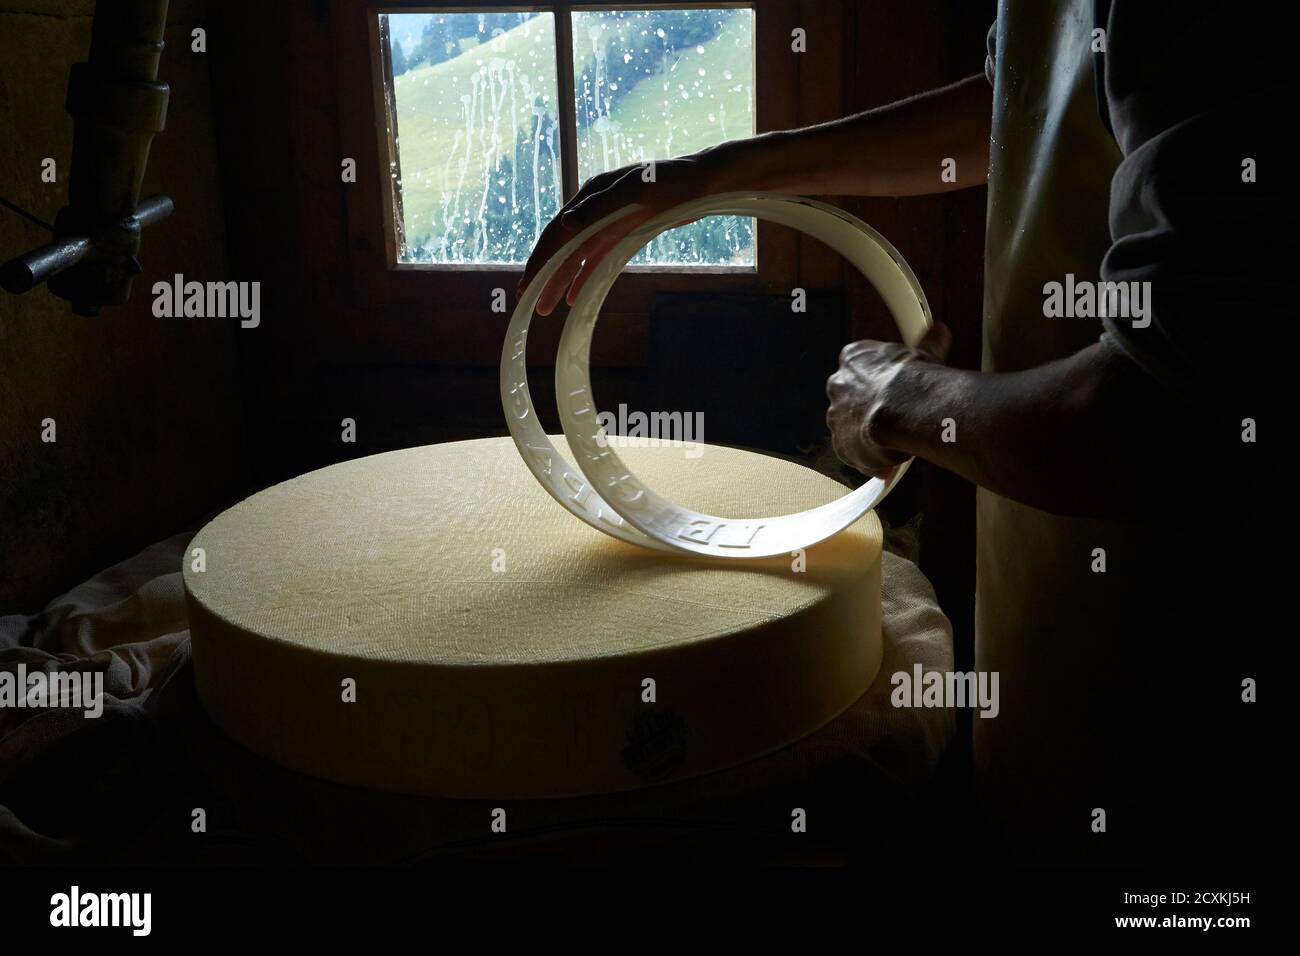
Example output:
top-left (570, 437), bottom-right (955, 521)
top-left (715, 74), bottom-right (993, 196)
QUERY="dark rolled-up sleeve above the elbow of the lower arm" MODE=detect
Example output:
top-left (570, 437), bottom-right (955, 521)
top-left (1101, 0), bottom-right (1300, 406)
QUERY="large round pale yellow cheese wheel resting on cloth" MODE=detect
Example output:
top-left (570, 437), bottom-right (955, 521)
top-left (185, 438), bottom-right (881, 799)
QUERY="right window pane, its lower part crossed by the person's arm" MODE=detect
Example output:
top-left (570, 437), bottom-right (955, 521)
top-left (572, 8), bottom-right (754, 265)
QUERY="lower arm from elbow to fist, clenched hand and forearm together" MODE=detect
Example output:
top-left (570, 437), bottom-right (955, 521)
top-left (826, 325), bottom-right (1222, 523)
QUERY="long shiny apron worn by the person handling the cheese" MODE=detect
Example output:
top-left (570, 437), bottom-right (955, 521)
top-left (974, 0), bottom-right (1242, 860)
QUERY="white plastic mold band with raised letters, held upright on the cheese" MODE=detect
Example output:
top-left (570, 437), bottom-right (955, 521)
top-left (501, 193), bottom-right (931, 558)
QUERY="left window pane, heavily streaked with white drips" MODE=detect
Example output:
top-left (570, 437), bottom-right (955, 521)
top-left (387, 13), bottom-right (563, 263)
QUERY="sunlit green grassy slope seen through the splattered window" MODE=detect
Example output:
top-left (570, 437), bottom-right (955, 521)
top-left (395, 20), bottom-right (753, 254)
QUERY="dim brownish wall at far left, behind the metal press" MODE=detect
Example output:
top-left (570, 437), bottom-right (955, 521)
top-left (0, 0), bottom-right (244, 614)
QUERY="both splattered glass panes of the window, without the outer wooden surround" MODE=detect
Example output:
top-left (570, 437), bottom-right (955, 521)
top-left (378, 5), bottom-right (755, 269)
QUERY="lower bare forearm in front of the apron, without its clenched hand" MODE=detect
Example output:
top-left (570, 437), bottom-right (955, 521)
top-left (868, 343), bottom-right (1211, 520)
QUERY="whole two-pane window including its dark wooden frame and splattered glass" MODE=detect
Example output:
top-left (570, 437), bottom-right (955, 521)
top-left (330, 0), bottom-right (826, 369)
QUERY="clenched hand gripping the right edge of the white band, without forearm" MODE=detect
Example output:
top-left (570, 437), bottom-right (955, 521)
top-left (826, 323), bottom-right (952, 477)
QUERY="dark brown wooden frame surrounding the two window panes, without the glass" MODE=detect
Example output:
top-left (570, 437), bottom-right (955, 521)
top-left (329, 0), bottom-right (842, 365)
